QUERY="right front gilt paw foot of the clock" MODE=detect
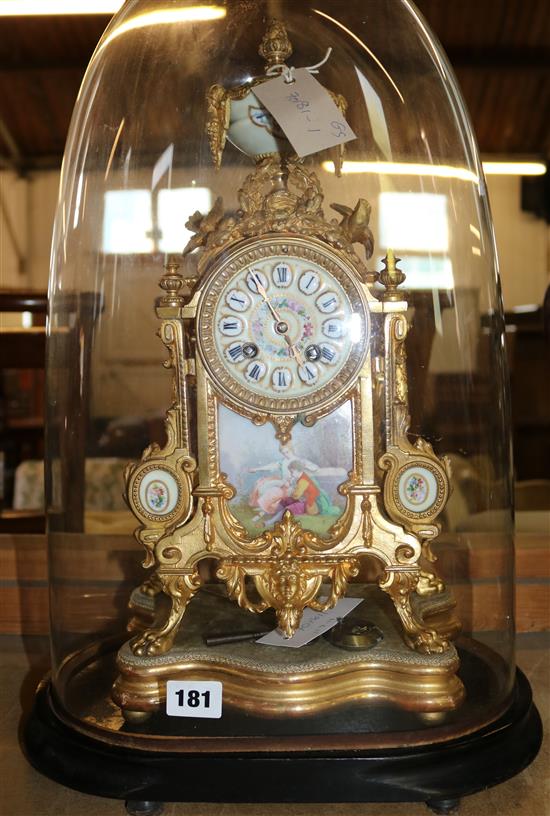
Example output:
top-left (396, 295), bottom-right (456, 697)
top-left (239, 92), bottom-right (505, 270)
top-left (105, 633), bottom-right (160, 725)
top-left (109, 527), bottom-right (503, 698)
top-left (379, 567), bottom-right (449, 654)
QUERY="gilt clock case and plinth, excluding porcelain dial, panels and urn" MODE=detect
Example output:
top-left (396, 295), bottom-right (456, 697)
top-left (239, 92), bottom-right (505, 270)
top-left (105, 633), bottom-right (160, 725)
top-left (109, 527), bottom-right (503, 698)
top-left (114, 139), bottom-right (464, 717)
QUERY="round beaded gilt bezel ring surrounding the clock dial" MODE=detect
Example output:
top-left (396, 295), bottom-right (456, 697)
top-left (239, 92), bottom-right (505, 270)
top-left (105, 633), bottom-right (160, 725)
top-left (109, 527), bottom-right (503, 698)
top-left (197, 234), bottom-right (370, 414)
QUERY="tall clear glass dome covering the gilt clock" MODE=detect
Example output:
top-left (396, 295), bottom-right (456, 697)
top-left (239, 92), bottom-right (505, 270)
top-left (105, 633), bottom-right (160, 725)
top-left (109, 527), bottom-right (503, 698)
top-left (47, 0), bottom-right (515, 750)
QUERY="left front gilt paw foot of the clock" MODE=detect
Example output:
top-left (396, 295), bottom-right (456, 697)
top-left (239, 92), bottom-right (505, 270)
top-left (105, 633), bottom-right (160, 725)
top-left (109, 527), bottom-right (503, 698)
top-left (130, 573), bottom-right (202, 657)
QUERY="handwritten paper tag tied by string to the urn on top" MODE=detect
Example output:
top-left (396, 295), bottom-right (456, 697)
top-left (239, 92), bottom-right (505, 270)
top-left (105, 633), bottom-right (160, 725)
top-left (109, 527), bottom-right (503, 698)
top-left (254, 68), bottom-right (357, 157)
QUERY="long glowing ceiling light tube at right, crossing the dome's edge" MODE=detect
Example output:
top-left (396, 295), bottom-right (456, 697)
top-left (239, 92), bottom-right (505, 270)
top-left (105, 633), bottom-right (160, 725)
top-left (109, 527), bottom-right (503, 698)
top-left (322, 161), bottom-right (546, 179)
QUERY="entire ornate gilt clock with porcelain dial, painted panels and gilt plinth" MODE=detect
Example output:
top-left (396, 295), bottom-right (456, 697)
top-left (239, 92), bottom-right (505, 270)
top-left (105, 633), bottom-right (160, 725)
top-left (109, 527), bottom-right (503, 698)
top-left (113, 23), bottom-right (463, 719)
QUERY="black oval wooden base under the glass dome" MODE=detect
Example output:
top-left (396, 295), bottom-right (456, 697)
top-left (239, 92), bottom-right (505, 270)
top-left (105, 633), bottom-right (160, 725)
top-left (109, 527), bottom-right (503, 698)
top-left (23, 670), bottom-right (542, 816)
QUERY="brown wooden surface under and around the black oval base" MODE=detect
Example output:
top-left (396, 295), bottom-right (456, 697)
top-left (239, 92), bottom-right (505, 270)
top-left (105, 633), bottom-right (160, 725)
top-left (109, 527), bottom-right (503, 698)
top-left (0, 634), bottom-right (550, 816)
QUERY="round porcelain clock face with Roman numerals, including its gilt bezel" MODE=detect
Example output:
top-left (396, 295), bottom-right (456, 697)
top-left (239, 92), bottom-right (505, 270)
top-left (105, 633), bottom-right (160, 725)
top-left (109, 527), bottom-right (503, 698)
top-left (198, 239), bottom-right (368, 412)
